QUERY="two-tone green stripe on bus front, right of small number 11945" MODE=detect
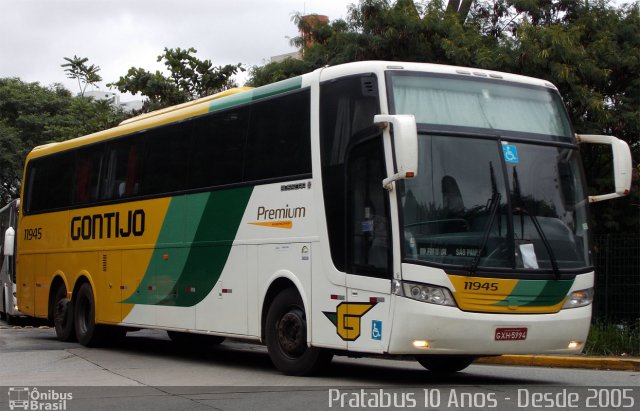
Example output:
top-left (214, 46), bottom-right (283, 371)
top-left (494, 280), bottom-right (574, 307)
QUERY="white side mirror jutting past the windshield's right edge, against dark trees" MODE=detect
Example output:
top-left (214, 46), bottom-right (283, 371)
top-left (576, 134), bottom-right (632, 203)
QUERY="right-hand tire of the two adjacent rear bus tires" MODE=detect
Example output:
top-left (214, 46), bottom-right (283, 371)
top-left (73, 283), bottom-right (103, 347)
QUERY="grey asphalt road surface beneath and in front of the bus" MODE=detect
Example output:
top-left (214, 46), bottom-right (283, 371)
top-left (0, 323), bottom-right (640, 411)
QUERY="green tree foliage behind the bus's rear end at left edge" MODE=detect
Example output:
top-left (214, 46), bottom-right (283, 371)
top-left (0, 78), bottom-right (124, 206)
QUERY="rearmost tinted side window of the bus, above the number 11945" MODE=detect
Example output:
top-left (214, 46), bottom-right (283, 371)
top-left (26, 152), bottom-right (74, 212)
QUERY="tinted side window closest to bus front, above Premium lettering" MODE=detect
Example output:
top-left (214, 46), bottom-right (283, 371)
top-left (244, 90), bottom-right (311, 181)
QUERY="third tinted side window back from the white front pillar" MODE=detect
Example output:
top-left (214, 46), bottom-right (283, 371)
top-left (144, 123), bottom-right (191, 195)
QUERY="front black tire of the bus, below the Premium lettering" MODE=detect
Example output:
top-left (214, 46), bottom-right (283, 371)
top-left (265, 288), bottom-right (333, 375)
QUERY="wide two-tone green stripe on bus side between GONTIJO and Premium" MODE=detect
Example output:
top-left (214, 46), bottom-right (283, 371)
top-left (123, 187), bottom-right (253, 307)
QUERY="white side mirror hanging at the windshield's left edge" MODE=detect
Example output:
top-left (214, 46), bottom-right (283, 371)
top-left (373, 114), bottom-right (418, 190)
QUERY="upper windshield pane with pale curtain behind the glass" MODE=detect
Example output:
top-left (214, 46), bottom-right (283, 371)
top-left (389, 72), bottom-right (574, 142)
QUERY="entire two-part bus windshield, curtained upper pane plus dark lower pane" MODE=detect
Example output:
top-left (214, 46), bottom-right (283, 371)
top-left (390, 75), bottom-right (591, 274)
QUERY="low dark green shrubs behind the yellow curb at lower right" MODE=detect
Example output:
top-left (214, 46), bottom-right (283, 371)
top-left (584, 321), bottom-right (640, 357)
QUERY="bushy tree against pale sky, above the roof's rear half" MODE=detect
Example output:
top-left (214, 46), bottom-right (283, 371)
top-left (108, 47), bottom-right (244, 112)
